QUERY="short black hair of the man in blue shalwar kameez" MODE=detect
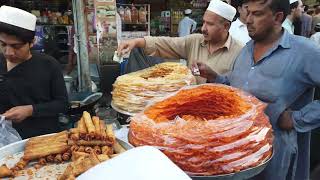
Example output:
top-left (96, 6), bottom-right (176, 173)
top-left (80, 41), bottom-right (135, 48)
top-left (245, 0), bottom-right (290, 22)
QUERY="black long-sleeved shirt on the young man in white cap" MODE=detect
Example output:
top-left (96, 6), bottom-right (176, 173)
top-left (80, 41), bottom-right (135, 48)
top-left (0, 53), bottom-right (68, 138)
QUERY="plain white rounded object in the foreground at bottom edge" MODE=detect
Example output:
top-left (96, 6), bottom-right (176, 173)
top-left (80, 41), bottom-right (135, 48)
top-left (77, 146), bottom-right (191, 180)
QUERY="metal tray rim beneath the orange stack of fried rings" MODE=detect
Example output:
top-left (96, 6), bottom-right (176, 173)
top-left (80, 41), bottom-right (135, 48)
top-left (190, 154), bottom-right (273, 180)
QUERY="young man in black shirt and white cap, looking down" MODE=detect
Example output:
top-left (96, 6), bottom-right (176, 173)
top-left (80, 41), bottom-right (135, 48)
top-left (0, 6), bottom-right (68, 138)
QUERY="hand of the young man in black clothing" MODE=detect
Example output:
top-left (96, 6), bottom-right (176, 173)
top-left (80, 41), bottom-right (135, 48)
top-left (2, 105), bottom-right (33, 123)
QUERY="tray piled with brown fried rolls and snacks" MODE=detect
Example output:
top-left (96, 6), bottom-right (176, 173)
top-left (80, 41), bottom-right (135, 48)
top-left (0, 112), bottom-right (132, 180)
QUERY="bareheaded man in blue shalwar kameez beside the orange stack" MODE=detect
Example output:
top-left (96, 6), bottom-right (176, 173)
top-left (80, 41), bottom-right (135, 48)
top-left (197, 0), bottom-right (320, 180)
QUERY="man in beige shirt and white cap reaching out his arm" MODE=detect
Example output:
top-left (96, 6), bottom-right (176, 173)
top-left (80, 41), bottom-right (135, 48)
top-left (117, 0), bottom-right (243, 83)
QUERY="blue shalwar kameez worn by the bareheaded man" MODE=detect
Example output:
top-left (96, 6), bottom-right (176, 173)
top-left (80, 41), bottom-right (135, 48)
top-left (216, 31), bottom-right (320, 180)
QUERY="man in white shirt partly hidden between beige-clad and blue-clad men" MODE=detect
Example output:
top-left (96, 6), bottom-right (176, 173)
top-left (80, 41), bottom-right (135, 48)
top-left (229, 0), bottom-right (251, 45)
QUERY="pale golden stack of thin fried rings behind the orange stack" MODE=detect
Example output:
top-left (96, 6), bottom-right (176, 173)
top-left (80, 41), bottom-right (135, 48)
top-left (112, 62), bottom-right (195, 114)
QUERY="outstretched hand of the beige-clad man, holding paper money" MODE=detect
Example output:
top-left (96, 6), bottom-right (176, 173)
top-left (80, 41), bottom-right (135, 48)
top-left (117, 38), bottom-right (146, 57)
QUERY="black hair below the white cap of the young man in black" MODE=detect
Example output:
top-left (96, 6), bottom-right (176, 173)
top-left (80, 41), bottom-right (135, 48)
top-left (0, 22), bottom-right (35, 43)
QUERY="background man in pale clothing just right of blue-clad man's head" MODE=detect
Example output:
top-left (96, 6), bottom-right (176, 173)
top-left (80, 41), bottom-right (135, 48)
top-left (282, 0), bottom-right (303, 34)
